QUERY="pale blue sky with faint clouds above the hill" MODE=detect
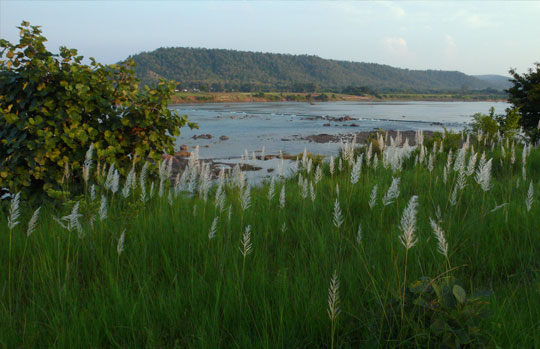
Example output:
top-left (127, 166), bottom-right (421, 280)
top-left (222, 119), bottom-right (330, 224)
top-left (0, 0), bottom-right (540, 75)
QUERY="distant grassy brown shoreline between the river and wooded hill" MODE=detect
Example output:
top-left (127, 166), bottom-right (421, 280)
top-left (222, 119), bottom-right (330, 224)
top-left (171, 92), bottom-right (507, 105)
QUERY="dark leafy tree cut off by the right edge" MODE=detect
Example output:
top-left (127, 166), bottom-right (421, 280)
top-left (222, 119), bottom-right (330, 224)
top-left (507, 63), bottom-right (540, 131)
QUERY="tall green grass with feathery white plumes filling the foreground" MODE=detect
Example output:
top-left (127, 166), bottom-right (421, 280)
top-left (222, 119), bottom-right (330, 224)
top-left (0, 133), bottom-right (540, 348)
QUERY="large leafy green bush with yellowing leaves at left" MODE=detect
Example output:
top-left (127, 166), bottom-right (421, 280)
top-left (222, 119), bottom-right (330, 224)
top-left (0, 22), bottom-right (196, 196)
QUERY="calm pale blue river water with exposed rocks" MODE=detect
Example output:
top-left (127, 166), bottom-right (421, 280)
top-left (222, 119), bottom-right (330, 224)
top-left (172, 102), bottom-right (510, 158)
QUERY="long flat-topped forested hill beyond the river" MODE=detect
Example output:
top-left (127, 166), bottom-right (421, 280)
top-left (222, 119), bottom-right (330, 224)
top-left (130, 47), bottom-right (508, 92)
